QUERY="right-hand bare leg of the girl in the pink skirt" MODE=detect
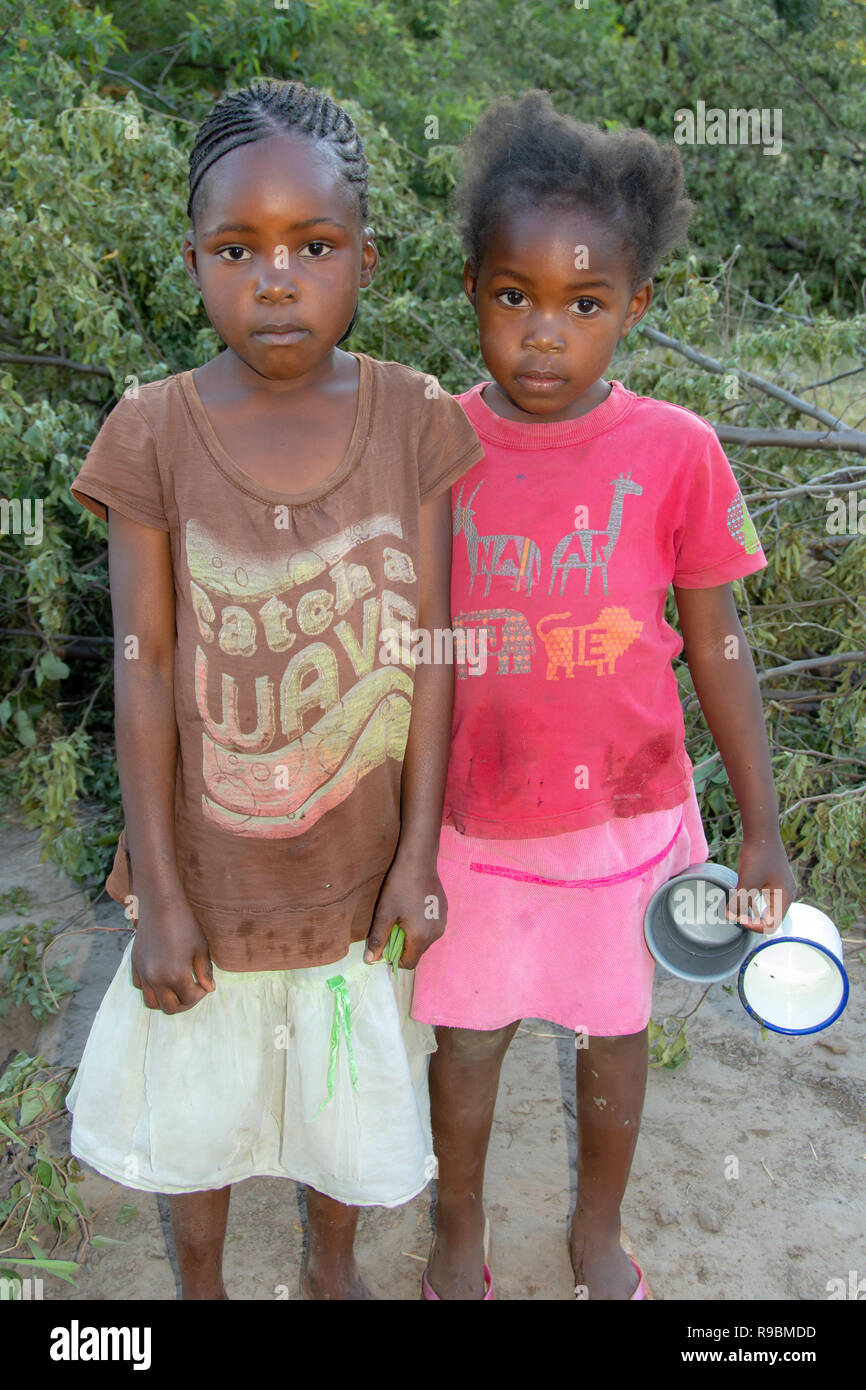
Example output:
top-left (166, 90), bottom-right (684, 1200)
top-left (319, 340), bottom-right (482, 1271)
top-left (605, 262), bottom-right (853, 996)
top-left (570, 1029), bottom-right (648, 1298)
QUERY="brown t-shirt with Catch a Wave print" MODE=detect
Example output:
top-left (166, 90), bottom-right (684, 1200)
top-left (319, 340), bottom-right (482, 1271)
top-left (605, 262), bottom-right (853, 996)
top-left (71, 353), bottom-right (482, 970)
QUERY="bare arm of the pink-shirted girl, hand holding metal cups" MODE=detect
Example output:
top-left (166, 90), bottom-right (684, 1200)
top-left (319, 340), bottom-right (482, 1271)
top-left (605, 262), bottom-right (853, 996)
top-left (674, 584), bottom-right (795, 930)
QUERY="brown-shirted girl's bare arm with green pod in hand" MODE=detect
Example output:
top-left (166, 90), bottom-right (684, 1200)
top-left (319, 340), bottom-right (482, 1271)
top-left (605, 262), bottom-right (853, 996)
top-left (367, 492), bottom-right (455, 970)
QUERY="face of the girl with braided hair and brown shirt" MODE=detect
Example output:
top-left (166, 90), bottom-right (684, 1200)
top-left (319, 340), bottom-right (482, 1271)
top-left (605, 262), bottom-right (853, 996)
top-left (183, 135), bottom-right (378, 381)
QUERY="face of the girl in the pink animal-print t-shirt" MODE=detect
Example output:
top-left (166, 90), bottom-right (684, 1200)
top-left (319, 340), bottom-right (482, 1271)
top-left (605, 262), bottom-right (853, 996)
top-left (463, 207), bottom-right (652, 421)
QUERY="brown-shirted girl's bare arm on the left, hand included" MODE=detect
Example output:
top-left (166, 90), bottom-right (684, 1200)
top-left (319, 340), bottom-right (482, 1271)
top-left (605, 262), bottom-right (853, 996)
top-left (108, 512), bottom-right (213, 1013)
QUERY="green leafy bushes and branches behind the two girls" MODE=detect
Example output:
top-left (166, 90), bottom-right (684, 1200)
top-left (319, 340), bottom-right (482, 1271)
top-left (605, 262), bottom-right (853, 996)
top-left (0, 0), bottom-right (866, 923)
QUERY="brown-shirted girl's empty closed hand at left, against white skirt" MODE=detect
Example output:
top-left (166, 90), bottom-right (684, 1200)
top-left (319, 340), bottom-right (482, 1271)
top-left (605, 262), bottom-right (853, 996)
top-left (132, 895), bottom-right (215, 1013)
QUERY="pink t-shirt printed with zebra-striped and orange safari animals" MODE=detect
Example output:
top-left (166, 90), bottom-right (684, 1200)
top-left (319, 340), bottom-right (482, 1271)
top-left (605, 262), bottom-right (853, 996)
top-left (443, 369), bottom-right (767, 840)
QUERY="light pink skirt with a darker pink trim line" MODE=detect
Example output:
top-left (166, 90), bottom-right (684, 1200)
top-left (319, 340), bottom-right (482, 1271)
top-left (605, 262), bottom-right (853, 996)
top-left (411, 785), bottom-right (709, 1037)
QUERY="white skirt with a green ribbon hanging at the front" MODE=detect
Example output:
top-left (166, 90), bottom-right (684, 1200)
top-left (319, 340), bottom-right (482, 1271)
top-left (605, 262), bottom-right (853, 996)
top-left (67, 941), bottom-right (436, 1207)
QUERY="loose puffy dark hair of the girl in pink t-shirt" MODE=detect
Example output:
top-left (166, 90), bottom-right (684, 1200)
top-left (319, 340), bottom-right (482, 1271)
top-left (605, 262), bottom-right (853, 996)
top-left (453, 90), bottom-right (694, 289)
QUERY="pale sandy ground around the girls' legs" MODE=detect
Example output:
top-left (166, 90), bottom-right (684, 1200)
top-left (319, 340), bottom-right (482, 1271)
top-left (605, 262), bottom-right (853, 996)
top-left (0, 823), bottom-right (866, 1301)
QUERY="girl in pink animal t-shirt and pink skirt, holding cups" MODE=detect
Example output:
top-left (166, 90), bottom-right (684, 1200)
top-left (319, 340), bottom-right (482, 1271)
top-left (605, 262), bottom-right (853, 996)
top-left (413, 92), bottom-right (794, 1300)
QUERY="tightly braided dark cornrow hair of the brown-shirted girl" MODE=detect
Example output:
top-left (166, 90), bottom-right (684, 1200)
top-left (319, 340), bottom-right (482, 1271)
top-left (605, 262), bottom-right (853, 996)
top-left (186, 78), bottom-right (370, 227)
